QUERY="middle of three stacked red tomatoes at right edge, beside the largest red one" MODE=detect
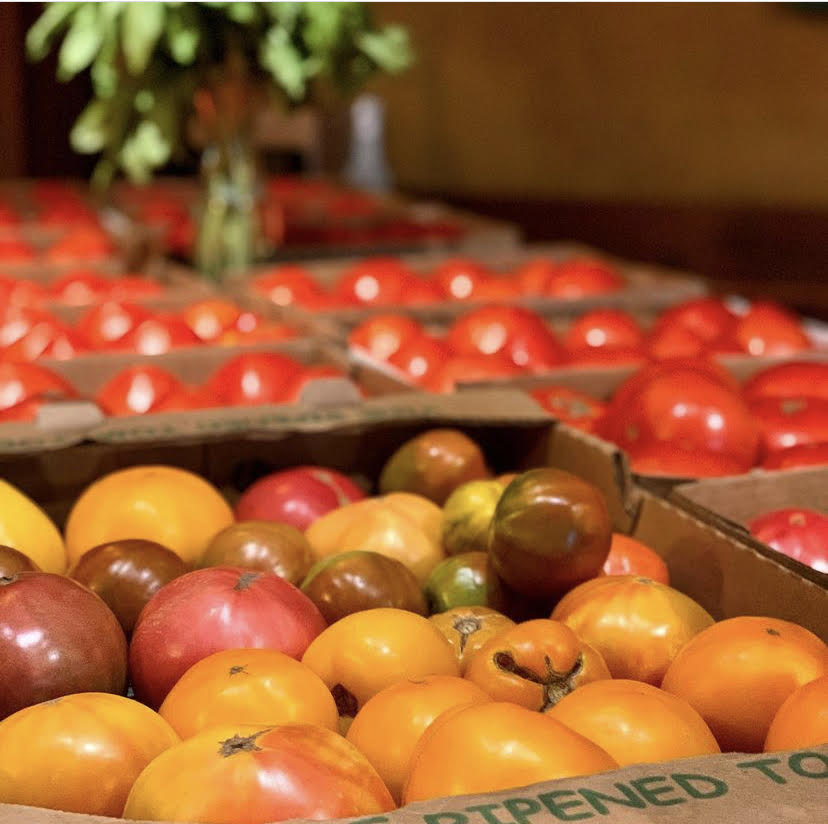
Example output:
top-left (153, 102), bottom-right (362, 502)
top-left (750, 398), bottom-right (828, 454)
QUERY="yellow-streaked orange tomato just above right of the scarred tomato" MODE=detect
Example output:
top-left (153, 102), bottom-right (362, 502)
top-left (552, 575), bottom-right (713, 686)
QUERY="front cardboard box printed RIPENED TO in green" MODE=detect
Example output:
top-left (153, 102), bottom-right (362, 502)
top-left (0, 392), bottom-right (828, 824)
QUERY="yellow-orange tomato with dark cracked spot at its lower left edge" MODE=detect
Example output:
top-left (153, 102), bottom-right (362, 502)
top-left (302, 608), bottom-right (460, 716)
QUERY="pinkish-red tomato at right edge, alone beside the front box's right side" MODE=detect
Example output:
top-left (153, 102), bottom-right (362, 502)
top-left (748, 508), bottom-right (828, 572)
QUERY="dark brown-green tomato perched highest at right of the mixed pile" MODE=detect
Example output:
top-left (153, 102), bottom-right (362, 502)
top-left (489, 467), bottom-right (612, 599)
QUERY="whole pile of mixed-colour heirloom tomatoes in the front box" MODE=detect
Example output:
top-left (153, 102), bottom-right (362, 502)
top-left (0, 429), bottom-right (828, 824)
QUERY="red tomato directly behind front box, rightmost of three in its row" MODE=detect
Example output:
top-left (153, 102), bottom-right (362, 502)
top-left (206, 352), bottom-right (303, 406)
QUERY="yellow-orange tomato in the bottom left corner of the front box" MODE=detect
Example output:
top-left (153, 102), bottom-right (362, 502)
top-left (0, 692), bottom-right (178, 817)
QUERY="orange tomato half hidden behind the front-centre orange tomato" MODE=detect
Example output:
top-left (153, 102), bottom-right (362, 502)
top-left (346, 675), bottom-right (492, 802)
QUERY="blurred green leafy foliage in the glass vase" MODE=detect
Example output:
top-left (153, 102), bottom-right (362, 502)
top-left (26, 2), bottom-right (411, 187)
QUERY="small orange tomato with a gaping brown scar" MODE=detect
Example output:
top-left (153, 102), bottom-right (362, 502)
top-left (465, 618), bottom-right (610, 712)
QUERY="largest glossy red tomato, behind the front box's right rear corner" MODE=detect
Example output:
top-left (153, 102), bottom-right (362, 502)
top-left (600, 365), bottom-right (759, 470)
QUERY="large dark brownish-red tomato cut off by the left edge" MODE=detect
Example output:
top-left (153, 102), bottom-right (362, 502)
top-left (0, 572), bottom-right (127, 718)
